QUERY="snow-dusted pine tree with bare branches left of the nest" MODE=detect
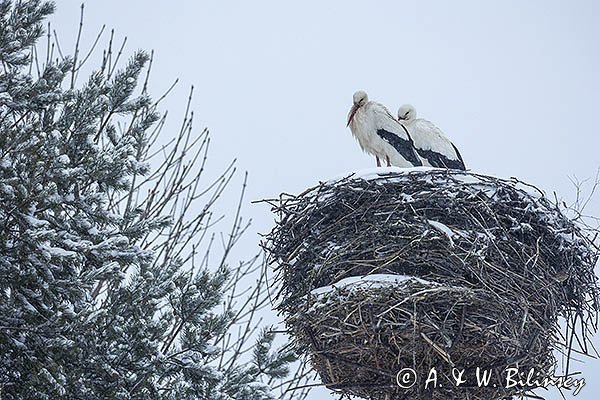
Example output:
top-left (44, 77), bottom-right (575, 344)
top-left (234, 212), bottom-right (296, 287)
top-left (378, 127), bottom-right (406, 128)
top-left (0, 0), bottom-right (294, 400)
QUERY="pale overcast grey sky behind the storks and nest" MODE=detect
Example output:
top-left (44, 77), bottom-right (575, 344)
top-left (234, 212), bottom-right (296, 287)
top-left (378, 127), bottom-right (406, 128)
top-left (51, 0), bottom-right (600, 400)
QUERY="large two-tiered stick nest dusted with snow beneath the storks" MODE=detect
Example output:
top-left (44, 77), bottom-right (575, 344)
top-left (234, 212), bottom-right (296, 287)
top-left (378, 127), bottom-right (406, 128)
top-left (263, 169), bottom-right (599, 399)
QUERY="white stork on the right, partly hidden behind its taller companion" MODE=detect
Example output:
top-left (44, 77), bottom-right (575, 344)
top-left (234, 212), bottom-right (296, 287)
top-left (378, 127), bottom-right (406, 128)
top-left (398, 104), bottom-right (466, 171)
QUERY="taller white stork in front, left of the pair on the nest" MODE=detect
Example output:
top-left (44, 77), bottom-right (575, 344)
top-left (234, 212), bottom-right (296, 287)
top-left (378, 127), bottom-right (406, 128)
top-left (346, 90), bottom-right (423, 167)
